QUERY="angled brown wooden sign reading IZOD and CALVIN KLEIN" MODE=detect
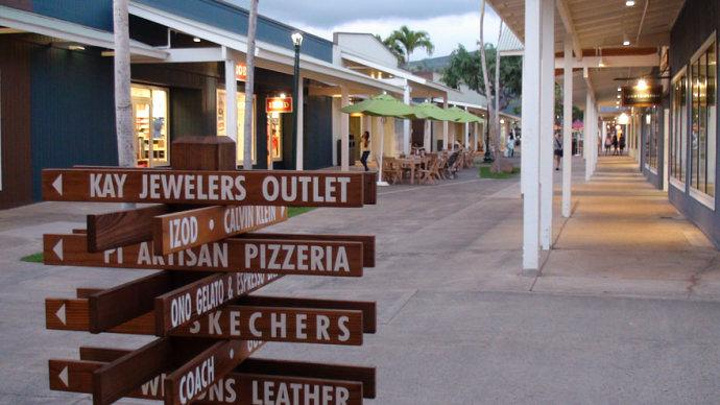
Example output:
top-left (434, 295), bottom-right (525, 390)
top-left (152, 205), bottom-right (287, 255)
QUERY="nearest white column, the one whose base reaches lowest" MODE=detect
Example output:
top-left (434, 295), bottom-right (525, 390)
top-left (521, 0), bottom-right (542, 275)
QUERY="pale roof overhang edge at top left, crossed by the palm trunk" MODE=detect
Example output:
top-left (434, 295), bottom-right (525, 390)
top-left (0, 6), bottom-right (167, 60)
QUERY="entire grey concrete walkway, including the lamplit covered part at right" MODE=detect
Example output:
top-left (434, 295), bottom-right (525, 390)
top-left (0, 158), bottom-right (720, 405)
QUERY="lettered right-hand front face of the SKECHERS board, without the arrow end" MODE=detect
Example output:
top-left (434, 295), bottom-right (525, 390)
top-left (172, 306), bottom-right (363, 346)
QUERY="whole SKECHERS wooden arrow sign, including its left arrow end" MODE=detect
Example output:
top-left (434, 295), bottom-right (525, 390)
top-left (45, 297), bottom-right (376, 345)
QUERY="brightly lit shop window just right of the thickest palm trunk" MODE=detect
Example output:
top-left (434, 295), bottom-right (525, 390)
top-left (131, 84), bottom-right (170, 167)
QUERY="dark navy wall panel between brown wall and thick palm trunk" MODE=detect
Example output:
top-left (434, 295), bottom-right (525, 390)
top-left (30, 47), bottom-right (117, 199)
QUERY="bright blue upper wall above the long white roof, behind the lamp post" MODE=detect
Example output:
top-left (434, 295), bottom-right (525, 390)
top-left (134, 0), bottom-right (333, 62)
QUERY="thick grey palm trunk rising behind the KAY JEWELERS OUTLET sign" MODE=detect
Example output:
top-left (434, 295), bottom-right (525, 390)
top-left (113, 0), bottom-right (137, 167)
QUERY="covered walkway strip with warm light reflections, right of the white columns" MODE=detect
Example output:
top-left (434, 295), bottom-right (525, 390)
top-left (532, 157), bottom-right (720, 299)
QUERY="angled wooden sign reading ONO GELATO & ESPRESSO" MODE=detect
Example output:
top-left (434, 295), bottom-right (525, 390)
top-left (154, 273), bottom-right (278, 336)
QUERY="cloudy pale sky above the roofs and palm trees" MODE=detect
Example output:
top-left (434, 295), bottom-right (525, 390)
top-left (225, 0), bottom-right (500, 61)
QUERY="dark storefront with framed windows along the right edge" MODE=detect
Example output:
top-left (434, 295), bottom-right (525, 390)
top-left (668, 0), bottom-right (720, 246)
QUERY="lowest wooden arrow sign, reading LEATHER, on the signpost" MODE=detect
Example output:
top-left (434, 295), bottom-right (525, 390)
top-left (49, 359), bottom-right (366, 405)
